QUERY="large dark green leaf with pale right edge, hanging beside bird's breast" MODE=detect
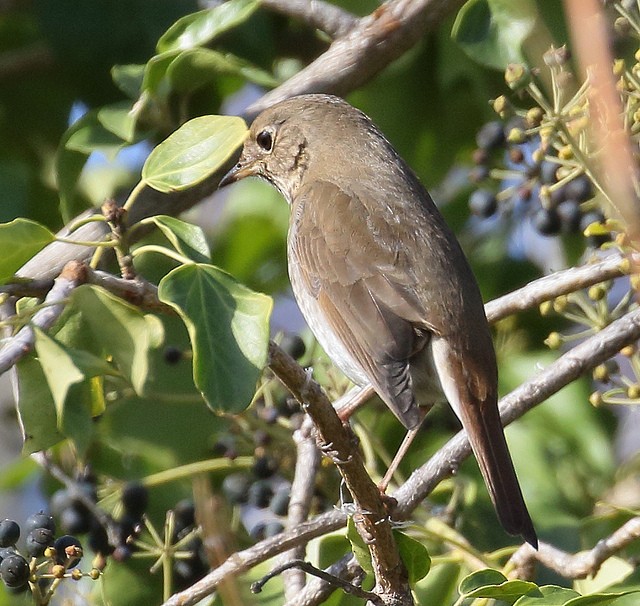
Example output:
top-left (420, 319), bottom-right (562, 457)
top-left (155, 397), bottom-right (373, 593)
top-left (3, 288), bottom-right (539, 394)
top-left (158, 263), bottom-right (273, 412)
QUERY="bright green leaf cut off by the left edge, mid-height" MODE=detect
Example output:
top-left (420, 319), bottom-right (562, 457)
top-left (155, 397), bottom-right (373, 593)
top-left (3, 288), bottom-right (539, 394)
top-left (0, 219), bottom-right (56, 282)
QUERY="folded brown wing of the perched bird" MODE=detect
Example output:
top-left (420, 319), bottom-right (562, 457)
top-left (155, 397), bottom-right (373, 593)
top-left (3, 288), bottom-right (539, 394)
top-left (290, 181), bottom-right (433, 427)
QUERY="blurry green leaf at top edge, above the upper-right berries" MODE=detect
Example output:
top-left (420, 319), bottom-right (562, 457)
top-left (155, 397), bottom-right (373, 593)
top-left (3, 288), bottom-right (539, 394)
top-left (451, 0), bottom-right (537, 69)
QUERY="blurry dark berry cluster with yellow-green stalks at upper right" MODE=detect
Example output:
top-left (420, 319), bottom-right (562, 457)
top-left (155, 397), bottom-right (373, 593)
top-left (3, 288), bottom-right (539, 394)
top-left (469, 47), bottom-right (610, 247)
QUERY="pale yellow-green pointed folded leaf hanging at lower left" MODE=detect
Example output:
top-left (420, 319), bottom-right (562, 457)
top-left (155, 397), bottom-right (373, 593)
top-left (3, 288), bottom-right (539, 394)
top-left (35, 328), bottom-right (118, 429)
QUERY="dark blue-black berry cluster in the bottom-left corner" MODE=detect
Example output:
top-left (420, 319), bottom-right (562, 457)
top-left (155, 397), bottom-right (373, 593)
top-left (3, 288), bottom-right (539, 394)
top-left (0, 511), bottom-right (100, 604)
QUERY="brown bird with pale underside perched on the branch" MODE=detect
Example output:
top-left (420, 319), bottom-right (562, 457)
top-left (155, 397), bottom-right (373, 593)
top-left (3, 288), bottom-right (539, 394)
top-left (221, 95), bottom-right (537, 547)
